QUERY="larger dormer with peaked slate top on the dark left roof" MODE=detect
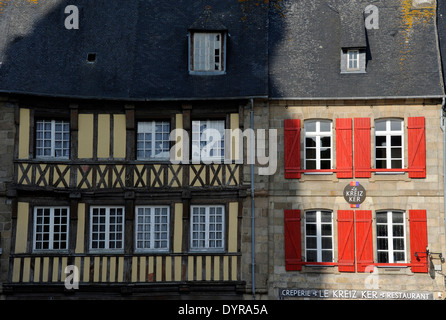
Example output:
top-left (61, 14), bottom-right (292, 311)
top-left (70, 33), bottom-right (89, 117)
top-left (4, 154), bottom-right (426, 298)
top-left (189, 6), bottom-right (228, 75)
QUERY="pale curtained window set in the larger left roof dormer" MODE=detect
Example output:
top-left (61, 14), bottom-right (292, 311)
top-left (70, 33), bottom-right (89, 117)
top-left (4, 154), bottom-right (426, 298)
top-left (190, 32), bottom-right (226, 75)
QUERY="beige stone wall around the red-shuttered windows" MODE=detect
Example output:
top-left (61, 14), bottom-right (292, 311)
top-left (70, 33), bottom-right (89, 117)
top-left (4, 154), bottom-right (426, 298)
top-left (242, 99), bottom-right (446, 299)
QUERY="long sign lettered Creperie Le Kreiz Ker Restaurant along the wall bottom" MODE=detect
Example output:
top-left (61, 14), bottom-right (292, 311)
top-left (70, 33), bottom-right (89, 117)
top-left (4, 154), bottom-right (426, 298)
top-left (279, 289), bottom-right (434, 300)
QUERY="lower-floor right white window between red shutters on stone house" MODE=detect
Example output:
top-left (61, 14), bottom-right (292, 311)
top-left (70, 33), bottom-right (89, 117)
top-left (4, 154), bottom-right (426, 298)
top-left (376, 211), bottom-right (407, 263)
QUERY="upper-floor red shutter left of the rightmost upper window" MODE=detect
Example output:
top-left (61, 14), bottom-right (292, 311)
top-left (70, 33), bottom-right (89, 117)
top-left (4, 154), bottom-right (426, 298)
top-left (354, 118), bottom-right (372, 178)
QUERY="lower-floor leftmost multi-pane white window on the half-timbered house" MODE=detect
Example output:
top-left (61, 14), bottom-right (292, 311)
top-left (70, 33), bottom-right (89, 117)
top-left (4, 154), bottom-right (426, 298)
top-left (33, 207), bottom-right (70, 251)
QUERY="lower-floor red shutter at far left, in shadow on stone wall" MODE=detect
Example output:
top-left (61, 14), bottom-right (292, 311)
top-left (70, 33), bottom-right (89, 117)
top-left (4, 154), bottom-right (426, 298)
top-left (285, 210), bottom-right (302, 271)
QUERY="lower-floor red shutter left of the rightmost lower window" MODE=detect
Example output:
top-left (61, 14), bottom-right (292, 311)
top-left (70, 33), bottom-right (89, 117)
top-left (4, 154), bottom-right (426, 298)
top-left (355, 210), bottom-right (373, 272)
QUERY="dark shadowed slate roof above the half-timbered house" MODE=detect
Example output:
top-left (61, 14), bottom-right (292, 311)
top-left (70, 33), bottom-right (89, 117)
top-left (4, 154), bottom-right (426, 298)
top-left (0, 0), bottom-right (268, 100)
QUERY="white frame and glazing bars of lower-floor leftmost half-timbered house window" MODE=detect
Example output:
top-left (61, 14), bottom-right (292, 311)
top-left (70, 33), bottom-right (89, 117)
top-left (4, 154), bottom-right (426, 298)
top-left (33, 206), bottom-right (70, 252)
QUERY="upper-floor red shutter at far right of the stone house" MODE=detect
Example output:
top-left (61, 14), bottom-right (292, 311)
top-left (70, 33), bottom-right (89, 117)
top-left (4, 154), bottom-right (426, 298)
top-left (407, 117), bottom-right (426, 178)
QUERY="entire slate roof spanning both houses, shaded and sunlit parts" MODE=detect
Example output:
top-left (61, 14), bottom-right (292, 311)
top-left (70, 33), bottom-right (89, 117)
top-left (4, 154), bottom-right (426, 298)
top-left (0, 0), bottom-right (446, 100)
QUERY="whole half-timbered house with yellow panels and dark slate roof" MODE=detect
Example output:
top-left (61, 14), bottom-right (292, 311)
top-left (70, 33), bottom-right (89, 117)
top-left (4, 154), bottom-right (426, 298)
top-left (0, 0), bottom-right (267, 299)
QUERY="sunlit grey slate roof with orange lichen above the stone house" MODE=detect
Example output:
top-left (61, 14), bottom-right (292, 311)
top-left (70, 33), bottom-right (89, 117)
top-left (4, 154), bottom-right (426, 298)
top-left (269, 0), bottom-right (444, 99)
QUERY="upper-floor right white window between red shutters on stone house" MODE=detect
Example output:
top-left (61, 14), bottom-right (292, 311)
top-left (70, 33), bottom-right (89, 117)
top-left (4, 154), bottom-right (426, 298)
top-left (375, 119), bottom-right (404, 169)
